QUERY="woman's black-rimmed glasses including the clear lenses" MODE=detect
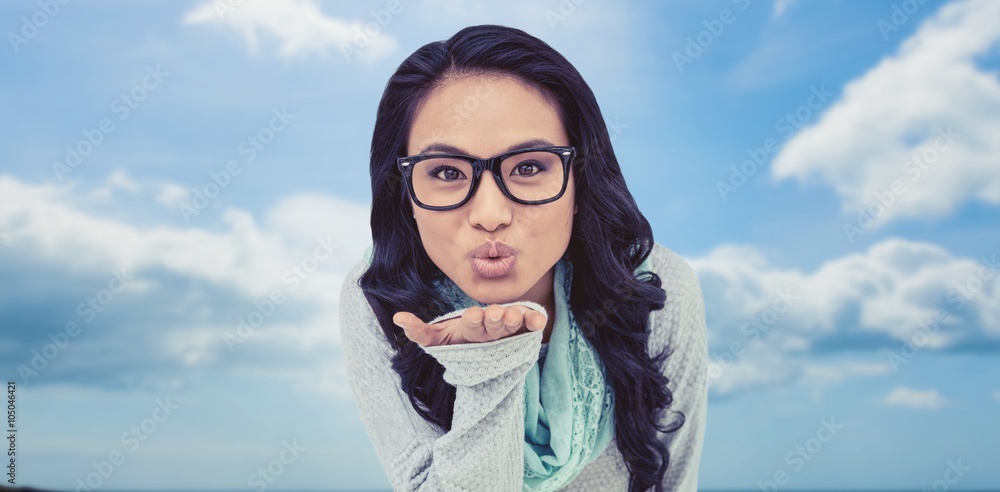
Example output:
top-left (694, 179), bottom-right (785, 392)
top-left (397, 147), bottom-right (576, 210)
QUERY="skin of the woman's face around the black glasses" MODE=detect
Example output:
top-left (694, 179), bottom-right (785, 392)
top-left (407, 75), bottom-right (575, 305)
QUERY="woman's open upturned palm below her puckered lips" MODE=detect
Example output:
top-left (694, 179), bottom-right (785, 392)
top-left (392, 304), bottom-right (548, 347)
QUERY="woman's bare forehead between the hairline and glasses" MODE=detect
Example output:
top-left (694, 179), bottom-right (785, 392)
top-left (407, 75), bottom-right (569, 157)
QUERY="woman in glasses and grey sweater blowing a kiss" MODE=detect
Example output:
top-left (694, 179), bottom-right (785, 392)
top-left (340, 26), bottom-right (707, 491)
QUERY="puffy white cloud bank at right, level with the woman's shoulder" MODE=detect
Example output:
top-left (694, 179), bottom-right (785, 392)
top-left (690, 239), bottom-right (1000, 350)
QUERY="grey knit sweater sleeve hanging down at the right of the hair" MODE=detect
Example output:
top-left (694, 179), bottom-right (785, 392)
top-left (651, 244), bottom-right (708, 492)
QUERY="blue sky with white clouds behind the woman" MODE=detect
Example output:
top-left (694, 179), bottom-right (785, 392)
top-left (0, 0), bottom-right (1000, 490)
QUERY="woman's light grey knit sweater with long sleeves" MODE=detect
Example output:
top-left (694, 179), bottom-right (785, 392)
top-left (340, 243), bottom-right (708, 492)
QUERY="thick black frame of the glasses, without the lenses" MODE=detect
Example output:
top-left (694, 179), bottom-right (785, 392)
top-left (396, 147), bottom-right (578, 210)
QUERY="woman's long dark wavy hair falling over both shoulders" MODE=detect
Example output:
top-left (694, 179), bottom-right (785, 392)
top-left (359, 25), bottom-right (684, 491)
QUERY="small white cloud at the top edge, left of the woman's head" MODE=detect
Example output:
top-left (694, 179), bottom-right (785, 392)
top-left (183, 0), bottom-right (396, 61)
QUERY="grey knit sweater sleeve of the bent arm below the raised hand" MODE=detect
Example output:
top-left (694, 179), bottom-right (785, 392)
top-left (340, 262), bottom-right (543, 491)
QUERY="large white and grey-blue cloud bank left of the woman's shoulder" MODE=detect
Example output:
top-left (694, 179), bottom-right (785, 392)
top-left (0, 175), bottom-right (371, 395)
